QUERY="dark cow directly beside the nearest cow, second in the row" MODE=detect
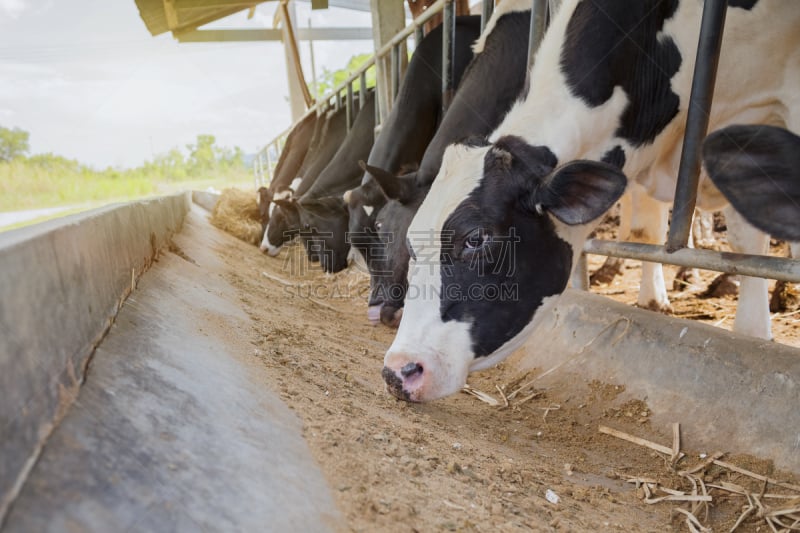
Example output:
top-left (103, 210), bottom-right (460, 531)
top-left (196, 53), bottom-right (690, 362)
top-left (348, 0), bottom-right (531, 327)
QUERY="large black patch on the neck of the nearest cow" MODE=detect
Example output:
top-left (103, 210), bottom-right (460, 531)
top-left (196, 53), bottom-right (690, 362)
top-left (561, 0), bottom-right (681, 146)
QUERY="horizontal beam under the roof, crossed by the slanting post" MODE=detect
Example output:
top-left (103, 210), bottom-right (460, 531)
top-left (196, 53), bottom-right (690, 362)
top-left (176, 28), bottom-right (372, 43)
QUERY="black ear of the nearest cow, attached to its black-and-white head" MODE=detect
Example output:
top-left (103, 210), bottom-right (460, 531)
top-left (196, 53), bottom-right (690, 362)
top-left (532, 160), bottom-right (628, 226)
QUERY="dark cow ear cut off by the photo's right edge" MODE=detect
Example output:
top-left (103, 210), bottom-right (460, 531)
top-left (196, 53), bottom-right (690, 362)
top-left (703, 126), bottom-right (800, 241)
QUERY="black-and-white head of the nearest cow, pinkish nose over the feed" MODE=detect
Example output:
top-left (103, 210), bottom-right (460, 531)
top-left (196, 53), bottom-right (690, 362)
top-left (383, 136), bottom-right (627, 401)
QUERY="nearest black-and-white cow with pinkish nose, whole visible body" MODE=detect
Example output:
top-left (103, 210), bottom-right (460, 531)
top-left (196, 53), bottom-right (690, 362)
top-left (383, 0), bottom-right (800, 401)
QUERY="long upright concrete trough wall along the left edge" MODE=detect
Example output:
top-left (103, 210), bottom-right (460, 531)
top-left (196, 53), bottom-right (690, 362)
top-left (0, 193), bottom-right (190, 517)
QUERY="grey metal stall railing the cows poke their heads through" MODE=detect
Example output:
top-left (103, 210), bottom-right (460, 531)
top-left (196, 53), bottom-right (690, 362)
top-left (254, 0), bottom-right (800, 289)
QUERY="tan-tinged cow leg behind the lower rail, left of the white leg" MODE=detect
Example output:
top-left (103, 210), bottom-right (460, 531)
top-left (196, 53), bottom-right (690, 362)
top-left (630, 186), bottom-right (672, 312)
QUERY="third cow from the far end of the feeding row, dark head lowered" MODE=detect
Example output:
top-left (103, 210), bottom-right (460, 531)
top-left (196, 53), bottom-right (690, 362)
top-left (267, 91), bottom-right (375, 272)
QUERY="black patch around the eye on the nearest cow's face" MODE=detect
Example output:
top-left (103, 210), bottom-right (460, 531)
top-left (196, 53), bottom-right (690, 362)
top-left (439, 137), bottom-right (572, 357)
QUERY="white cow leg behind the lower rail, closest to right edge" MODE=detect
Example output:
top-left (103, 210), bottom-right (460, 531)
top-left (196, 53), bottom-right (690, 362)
top-left (724, 206), bottom-right (772, 339)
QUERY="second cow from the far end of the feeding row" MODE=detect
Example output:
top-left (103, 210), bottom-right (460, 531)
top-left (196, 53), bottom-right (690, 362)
top-left (259, 106), bottom-right (347, 256)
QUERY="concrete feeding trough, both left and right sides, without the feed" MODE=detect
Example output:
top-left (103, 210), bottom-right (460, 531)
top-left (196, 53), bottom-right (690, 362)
top-left (0, 193), bottom-right (800, 531)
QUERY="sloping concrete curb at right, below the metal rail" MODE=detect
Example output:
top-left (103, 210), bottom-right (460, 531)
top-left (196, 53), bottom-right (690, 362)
top-left (511, 290), bottom-right (800, 472)
